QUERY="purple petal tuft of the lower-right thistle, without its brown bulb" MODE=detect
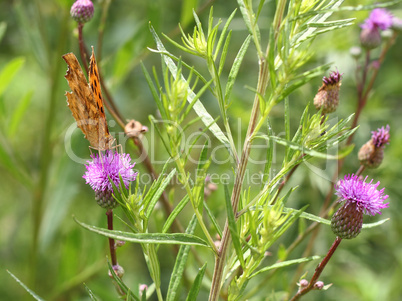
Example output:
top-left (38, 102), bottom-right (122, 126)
top-left (335, 174), bottom-right (389, 215)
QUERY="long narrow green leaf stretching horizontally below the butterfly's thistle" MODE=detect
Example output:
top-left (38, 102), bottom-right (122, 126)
top-left (74, 217), bottom-right (208, 247)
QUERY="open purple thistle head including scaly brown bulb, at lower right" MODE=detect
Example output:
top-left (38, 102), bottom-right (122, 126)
top-left (331, 174), bottom-right (389, 239)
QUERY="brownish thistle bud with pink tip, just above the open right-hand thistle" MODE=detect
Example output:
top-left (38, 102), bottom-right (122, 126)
top-left (357, 125), bottom-right (390, 168)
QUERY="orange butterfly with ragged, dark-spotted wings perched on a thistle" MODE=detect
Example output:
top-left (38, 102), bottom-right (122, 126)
top-left (63, 47), bottom-right (114, 151)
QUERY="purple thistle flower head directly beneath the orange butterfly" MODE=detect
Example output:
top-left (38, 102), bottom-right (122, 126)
top-left (83, 150), bottom-right (137, 208)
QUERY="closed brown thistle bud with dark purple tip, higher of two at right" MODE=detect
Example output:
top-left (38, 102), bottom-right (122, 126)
top-left (314, 71), bottom-right (342, 114)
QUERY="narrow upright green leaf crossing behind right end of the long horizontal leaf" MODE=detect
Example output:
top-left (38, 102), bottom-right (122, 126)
top-left (166, 215), bottom-right (197, 301)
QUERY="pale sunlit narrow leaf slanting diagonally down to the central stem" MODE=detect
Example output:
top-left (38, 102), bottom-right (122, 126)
top-left (150, 26), bottom-right (230, 149)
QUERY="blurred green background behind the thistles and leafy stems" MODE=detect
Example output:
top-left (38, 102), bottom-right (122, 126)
top-left (0, 0), bottom-right (402, 301)
